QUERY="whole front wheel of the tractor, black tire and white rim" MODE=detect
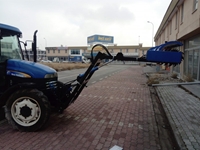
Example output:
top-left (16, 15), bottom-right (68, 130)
top-left (5, 89), bottom-right (50, 132)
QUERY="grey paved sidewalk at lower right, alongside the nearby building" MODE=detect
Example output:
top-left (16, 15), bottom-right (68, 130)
top-left (143, 67), bottom-right (200, 150)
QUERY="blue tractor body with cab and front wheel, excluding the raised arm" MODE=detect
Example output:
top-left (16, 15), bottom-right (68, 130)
top-left (0, 24), bottom-right (57, 131)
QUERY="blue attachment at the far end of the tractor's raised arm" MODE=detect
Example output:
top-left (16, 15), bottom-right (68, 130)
top-left (146, 41), bottom-right (183, 64)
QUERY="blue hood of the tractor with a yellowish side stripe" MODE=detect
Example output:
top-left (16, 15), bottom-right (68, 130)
top-left (6, 59), bottom-right (57, 78)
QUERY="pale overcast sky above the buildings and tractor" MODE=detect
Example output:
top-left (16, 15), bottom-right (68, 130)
top-left (0, 0), bottom-right (171, 49)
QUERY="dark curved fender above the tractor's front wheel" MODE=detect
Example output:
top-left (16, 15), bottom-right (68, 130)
top-left (0, 82), bottom-right (37, 107)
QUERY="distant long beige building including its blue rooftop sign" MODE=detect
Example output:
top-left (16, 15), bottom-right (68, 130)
top-left (46, 34), bottom-right (150, 62)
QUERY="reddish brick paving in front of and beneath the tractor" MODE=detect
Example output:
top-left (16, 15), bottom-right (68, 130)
top-left (0, 66), bottom-right (161, 150)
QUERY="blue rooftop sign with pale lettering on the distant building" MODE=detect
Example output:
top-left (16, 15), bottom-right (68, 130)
top-left (87, 35), bottom-right (114, 44)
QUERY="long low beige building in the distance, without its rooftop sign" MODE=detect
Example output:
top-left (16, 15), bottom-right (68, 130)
top-left (46, 44), bottom-right (150, 61)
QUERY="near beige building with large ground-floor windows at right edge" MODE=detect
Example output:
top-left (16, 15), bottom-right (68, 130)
top-left (154, 0), bottom-right (200, 80)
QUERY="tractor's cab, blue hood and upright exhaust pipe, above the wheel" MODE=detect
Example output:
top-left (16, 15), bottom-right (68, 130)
top-left (0, 24), bottom-right (57, 96)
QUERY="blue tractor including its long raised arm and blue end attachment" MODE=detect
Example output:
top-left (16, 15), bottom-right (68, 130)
top-left (0, 24), bottom-right (182, 132)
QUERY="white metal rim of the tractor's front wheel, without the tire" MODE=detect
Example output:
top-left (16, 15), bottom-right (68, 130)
top-left (11, 97), bottom-right (41, 126)
